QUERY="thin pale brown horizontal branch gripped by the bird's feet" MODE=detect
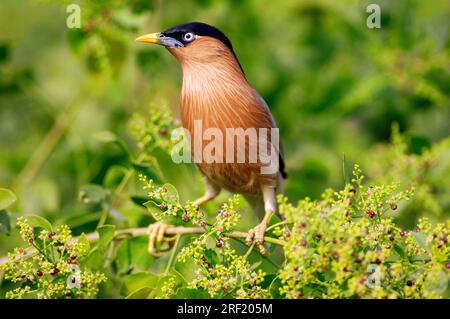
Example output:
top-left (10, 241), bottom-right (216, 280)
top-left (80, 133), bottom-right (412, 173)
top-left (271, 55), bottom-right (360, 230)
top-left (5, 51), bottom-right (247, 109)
top-left (0, 226), bottom-right (286, 265)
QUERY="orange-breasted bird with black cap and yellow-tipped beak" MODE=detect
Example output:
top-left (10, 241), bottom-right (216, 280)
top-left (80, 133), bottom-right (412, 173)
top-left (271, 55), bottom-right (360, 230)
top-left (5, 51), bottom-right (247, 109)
top-left (136, 22), bottom-right (287, 254)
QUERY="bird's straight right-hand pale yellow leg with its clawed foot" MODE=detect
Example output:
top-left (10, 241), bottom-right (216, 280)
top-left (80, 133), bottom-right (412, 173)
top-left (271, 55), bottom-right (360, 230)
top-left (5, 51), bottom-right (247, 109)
top-left (245, 186), bottom-right (277, 254)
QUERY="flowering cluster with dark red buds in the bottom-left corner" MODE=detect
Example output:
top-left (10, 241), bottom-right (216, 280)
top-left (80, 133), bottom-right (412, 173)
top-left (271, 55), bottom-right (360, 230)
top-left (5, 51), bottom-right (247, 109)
top-left (0, 216), bottom-right (106, 299)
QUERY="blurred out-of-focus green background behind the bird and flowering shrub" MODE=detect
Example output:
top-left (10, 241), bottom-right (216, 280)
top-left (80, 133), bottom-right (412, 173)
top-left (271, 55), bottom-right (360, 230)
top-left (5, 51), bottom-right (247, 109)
top-left (0, 0), bottom-right (450, 255)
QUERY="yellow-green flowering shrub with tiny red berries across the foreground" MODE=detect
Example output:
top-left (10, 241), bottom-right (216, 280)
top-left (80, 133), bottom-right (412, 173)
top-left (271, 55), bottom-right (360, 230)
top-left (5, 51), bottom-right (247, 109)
top-left (0, 108), bottom-right (450, 298)
